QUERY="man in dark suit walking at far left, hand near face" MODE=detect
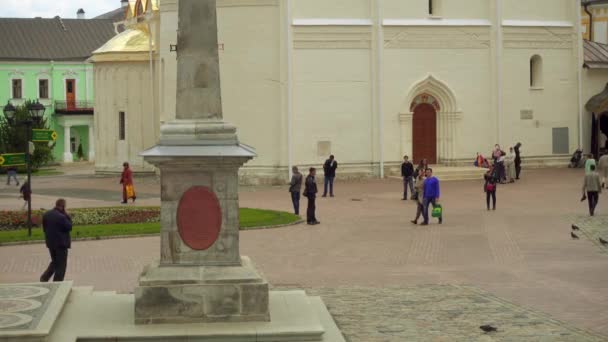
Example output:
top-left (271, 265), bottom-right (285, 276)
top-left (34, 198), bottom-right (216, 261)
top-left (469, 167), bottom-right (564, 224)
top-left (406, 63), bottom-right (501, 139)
top-left (40, 198), bottom-right (72, 282)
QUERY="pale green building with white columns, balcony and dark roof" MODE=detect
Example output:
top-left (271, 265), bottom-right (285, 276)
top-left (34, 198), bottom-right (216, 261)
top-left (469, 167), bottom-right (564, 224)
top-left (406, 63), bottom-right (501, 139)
top-left (0, 17), bottom-right (116, 163)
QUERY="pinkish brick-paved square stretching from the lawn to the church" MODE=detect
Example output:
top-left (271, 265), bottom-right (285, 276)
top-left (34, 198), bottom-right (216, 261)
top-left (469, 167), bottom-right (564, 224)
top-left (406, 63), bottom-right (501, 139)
top-left (0, 169), bottom-right (608, 342)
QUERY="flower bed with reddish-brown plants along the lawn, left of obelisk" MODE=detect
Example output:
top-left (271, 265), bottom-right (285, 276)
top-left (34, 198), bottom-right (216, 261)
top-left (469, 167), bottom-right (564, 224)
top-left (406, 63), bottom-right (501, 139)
top-left (0, 207), bottom-right (160, 230)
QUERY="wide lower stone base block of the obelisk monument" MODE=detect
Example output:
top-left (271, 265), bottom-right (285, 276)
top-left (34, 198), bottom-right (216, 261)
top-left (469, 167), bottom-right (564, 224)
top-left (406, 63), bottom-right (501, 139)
top-left (135, 257), bottom-right (270, 324)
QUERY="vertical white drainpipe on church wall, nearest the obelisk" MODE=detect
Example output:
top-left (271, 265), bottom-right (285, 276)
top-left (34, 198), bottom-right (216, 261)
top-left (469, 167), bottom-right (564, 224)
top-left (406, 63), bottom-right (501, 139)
top-left (285, 0), bottom-right (293, 181)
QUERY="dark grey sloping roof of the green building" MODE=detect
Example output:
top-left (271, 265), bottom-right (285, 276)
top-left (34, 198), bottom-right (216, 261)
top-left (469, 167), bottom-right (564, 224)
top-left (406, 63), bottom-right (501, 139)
top-left (0, 17), bottom-right (115, 61)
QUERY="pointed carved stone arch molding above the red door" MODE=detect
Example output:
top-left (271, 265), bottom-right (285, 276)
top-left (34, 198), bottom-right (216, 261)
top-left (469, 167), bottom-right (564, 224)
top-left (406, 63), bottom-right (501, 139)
top-left (401, 75), bottom-right (461, 117)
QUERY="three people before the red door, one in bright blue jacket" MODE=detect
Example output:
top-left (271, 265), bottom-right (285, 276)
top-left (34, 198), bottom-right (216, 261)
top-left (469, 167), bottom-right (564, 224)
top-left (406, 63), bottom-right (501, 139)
top-left (401, 156), bottom-right (443, 226)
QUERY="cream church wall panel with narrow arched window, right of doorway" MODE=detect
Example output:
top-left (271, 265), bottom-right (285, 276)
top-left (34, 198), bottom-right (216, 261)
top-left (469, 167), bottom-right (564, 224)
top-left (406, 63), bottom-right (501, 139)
top-left (502, 49), bottom-right (579, 156)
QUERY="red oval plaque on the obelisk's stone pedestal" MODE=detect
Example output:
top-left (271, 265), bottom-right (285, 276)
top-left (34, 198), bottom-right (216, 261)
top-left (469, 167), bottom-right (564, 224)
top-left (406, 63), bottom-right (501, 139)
top-left (177, 186), bottom-right (222, 251)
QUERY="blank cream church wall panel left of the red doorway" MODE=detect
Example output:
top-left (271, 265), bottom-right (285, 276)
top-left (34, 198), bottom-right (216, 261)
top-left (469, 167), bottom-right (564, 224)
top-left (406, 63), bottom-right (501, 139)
top-left (293, 48), bottom-right (373, 168)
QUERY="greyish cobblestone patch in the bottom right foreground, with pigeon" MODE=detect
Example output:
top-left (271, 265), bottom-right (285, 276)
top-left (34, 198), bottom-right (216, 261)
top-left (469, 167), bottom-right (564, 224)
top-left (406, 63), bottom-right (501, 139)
top-left (274, 285), bottom-right (607, 342)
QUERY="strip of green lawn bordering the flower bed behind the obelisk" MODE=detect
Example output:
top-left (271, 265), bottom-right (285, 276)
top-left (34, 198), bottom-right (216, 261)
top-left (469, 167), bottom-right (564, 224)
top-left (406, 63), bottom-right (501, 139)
top-left (0, 208), bottom-right (300, 244)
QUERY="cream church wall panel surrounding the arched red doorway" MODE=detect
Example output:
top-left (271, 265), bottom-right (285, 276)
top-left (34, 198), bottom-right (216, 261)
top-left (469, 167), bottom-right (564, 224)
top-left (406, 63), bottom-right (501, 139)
top-left (383, 42), bottom-right (496, 162)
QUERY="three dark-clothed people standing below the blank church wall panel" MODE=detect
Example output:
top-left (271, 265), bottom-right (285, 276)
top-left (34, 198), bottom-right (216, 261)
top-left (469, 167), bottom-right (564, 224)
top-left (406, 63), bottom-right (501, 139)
top-left (289, 155), bottom-right (338, 225)
